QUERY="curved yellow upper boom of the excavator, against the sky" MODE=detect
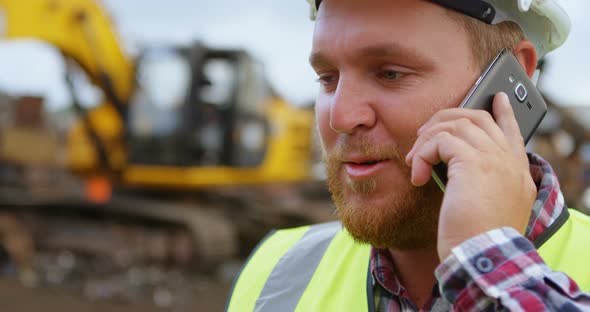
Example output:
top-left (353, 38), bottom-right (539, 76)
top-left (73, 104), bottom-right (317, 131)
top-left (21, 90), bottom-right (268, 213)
top-left (0, 0), bottom-right (134, 107)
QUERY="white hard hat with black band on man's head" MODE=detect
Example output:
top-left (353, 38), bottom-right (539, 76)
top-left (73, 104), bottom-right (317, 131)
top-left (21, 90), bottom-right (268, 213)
top-left (307, 0), bottom-right (571, 59)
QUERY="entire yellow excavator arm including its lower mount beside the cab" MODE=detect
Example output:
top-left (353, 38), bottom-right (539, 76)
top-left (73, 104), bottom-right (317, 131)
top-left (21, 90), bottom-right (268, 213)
top-left (0, 0), bottom-right (135, 173)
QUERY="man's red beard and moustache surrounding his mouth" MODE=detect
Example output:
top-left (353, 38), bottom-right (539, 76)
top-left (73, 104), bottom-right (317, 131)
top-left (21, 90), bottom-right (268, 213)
top-left (325, 137), bottom-right (442, 250)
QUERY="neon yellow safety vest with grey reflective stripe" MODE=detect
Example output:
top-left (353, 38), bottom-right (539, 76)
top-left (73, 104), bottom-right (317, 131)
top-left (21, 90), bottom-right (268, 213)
top-left (228, 210), bottom-right (590, 312)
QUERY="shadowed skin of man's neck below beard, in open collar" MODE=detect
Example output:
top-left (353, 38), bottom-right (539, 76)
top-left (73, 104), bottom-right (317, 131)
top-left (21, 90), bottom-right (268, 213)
top-left (389, 246), bottom-right (440, 308)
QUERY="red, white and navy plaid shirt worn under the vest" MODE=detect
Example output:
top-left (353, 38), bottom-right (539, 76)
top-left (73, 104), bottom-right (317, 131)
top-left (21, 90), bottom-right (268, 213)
top-left (371, 154), bottom-right (590, 312)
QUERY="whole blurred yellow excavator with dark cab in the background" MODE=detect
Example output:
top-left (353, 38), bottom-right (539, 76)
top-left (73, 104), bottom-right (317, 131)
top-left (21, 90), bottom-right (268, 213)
top-left (0, 0), bottom-right (324, 268)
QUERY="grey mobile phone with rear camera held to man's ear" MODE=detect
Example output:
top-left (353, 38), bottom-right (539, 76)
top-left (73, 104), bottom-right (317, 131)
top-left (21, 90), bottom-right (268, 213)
top-left (432, 49), bottom-right (547, 192)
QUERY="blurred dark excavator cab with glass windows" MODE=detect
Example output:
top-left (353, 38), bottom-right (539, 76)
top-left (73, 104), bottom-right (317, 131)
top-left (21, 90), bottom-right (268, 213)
top-left (126, 43), bottom-right (273, 167)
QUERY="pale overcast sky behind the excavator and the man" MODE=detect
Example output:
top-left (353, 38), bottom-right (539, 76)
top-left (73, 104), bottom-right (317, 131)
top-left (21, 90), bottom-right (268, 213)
top-left (0, 0), bottom-right (590, 109)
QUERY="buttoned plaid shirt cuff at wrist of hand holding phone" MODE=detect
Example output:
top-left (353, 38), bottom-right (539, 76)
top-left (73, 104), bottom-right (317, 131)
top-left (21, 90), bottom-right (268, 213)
top-left (435, 227), bottom-right (547, 304)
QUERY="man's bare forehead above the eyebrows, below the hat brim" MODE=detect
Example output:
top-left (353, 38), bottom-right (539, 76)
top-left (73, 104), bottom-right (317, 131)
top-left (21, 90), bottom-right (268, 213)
top-left (313, 0), bottom-right (459, 55)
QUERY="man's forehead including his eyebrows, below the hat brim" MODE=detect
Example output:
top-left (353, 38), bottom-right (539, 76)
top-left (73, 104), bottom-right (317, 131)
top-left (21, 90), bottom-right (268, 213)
top-left (310, 0), bottom-right (469, 69)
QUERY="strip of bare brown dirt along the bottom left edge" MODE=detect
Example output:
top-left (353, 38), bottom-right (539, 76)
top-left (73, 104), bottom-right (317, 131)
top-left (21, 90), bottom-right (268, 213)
top-left (0, 279), bottom-right (231, 312)
